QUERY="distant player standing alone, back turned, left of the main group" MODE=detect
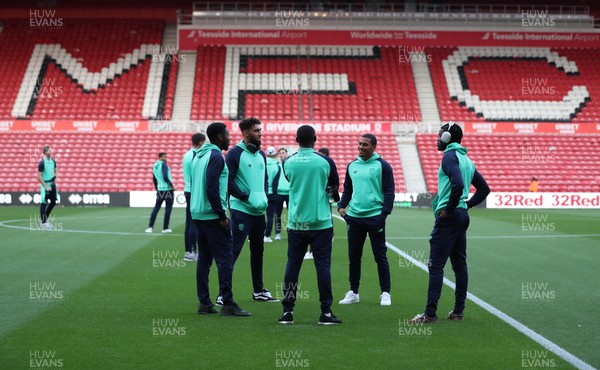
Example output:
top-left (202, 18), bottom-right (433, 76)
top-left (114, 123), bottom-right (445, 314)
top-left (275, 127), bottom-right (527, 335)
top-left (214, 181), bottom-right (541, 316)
top-left (146, 152), bottom-right (175, 233)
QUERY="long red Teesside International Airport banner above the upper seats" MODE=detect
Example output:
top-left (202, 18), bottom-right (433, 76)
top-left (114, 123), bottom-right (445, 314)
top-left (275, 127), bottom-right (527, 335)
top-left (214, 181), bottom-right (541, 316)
top-left (178, 26), bottom-right (600, 51)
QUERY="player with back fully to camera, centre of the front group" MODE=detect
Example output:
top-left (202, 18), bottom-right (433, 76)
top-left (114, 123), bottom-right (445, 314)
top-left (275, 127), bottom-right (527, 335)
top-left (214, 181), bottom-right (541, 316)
top-left (279, 125), bottom-right (341, 325)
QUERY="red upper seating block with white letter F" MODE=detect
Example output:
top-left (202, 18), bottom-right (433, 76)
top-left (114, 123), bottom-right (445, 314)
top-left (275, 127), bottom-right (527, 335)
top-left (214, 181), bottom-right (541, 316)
top-left (191, 45), bottom-right (420, 121)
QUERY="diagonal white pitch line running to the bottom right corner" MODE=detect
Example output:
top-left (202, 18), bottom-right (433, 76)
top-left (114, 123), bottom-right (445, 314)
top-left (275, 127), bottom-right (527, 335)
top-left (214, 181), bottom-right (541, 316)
top-left (333, 215), bottom-right (594, 370)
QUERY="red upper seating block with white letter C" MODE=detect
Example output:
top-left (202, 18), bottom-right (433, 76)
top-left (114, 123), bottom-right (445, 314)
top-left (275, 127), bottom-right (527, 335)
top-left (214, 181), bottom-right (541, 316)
top-left (428, 47), bottom-right (600, 122)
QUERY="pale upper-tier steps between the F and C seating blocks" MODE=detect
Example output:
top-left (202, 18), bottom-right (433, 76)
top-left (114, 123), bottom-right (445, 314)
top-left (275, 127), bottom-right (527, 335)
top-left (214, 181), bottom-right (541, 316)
top-left (412, 52), bottom-right (441, 124)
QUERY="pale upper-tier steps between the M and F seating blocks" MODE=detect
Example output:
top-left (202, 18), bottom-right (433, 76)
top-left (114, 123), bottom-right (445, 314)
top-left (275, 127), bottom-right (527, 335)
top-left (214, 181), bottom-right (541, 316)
top-left (172, 52), bottom-right (198, 121)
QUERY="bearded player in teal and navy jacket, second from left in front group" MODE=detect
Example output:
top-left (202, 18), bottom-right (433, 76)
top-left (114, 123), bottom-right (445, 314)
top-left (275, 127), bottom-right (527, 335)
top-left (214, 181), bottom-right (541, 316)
top-left (223, 117), bottom-right (279, 304)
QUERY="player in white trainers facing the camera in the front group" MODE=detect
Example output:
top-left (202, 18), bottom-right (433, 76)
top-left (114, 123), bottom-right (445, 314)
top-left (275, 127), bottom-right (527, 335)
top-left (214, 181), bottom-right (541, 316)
top-left (338, 134), bottom-right (395, 306)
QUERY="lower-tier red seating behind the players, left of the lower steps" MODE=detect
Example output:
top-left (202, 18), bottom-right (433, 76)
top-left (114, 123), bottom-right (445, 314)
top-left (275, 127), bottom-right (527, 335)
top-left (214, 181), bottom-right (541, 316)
top-left (0, 127), bottom-right (405, 192)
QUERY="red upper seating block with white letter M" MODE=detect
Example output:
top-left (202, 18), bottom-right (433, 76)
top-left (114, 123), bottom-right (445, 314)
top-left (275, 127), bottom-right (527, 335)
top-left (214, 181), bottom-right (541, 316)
top-left (0, 19), bottom-right (177, 119)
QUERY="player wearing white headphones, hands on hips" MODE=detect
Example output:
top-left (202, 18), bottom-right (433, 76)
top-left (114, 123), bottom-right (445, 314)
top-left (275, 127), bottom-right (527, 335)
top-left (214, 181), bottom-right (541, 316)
top-left (411, 122), bottom-right (490, 323)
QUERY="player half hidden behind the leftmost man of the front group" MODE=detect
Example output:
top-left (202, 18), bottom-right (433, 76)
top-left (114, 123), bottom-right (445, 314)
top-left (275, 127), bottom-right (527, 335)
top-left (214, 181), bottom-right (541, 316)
top-left (181, 132), bottom-right (206, 261)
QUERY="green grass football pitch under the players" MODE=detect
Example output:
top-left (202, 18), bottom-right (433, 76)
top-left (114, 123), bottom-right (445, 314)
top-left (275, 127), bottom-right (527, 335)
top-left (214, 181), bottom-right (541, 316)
top-left (0, 207), bottom-right (600, 369)
